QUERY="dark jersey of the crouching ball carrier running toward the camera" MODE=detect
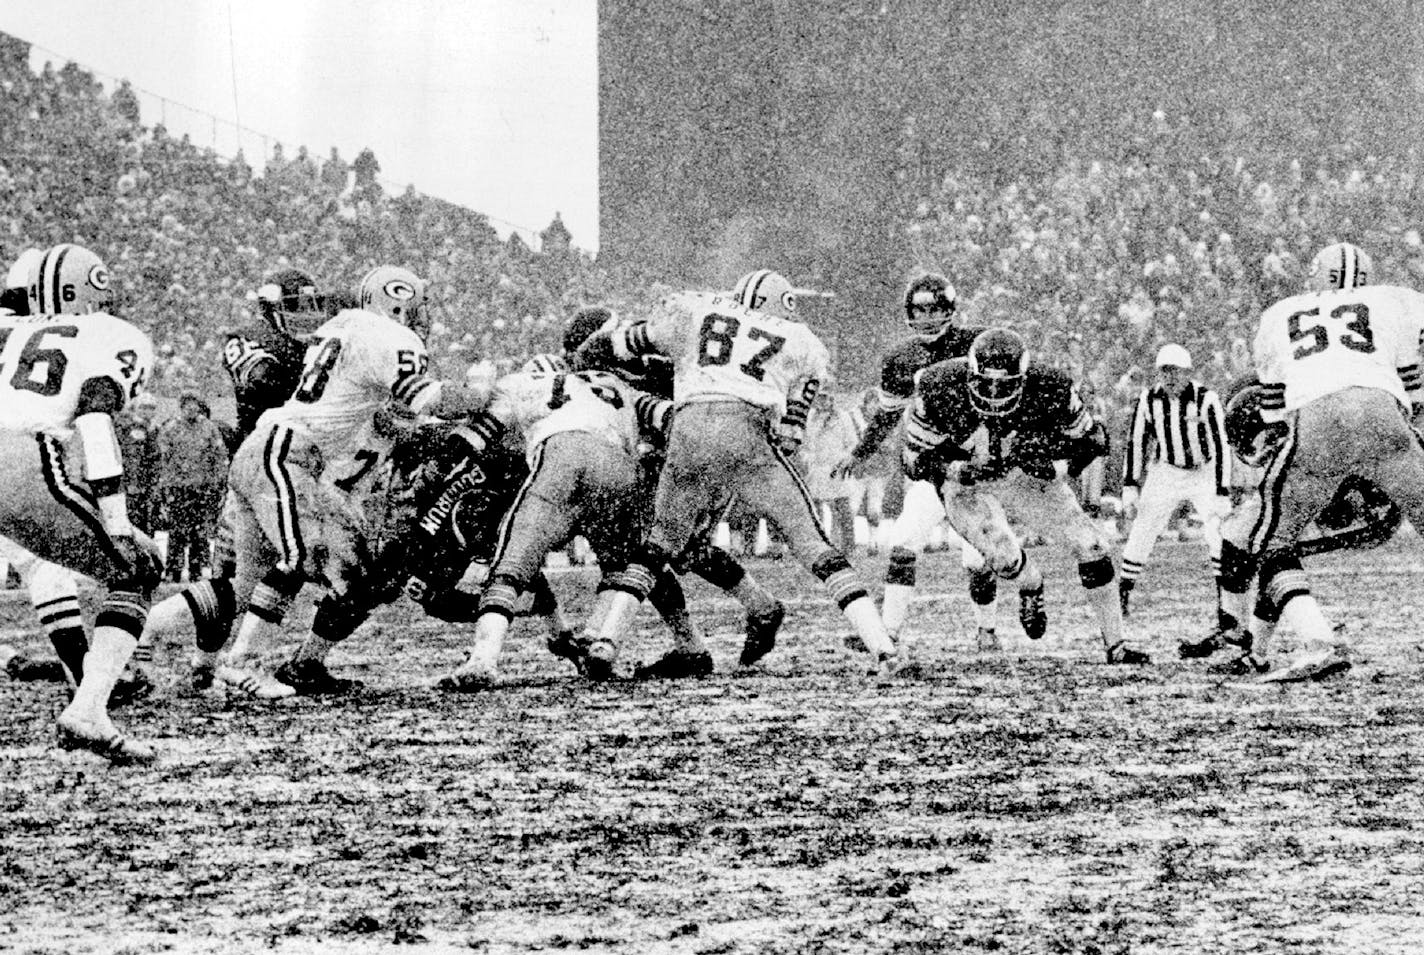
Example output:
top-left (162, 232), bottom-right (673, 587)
top-left (906, 359), bottom-right (1092, 474)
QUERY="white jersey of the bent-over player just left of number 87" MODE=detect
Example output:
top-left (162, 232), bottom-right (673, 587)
top-left (490, 371), bottom-right (638, 458)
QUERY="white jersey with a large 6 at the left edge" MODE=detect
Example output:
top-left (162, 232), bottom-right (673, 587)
top-left (0, 312), bottom-right (154, 438)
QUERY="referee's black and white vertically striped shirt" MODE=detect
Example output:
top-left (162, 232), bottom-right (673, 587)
top-left (1122, 381), bottom-right (1232, 494)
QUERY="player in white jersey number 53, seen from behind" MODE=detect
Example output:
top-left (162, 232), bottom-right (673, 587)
top-left (1222, 242), bottom-right (1424, 682)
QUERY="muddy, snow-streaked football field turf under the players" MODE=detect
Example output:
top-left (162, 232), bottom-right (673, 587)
top-left (0, 538), bottom-right (1424, 954)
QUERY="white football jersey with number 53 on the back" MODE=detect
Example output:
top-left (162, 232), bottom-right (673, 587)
top-left (1255, 285), bottom-right (1424, 411)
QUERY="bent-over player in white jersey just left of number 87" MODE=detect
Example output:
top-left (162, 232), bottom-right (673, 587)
top-left (439, 356), bottom-right (669, 692)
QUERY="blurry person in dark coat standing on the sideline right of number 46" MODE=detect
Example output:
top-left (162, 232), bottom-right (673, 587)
top-left (158, 393), bottom-right (228, 582)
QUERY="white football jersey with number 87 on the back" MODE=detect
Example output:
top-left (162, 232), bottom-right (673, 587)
top-left (646, 292), bottom-right (830, 417)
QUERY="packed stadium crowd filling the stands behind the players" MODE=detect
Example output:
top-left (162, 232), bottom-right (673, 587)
top-left (0, 34), bottom-right (1424, 560)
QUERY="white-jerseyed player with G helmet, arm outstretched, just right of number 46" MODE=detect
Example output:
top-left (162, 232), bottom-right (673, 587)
top-left (207, 266), bottom-right (490, 696)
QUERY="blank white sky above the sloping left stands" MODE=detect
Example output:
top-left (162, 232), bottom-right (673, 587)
top-left (0, 0), bottom-right (598, 249)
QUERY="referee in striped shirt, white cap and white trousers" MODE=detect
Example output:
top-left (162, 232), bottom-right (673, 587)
top-left (1118, 344), bottom-right (1236, 630)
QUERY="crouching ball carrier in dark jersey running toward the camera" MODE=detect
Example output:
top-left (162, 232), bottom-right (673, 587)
top-left (904, 327), bottom-right (1151, 663)
